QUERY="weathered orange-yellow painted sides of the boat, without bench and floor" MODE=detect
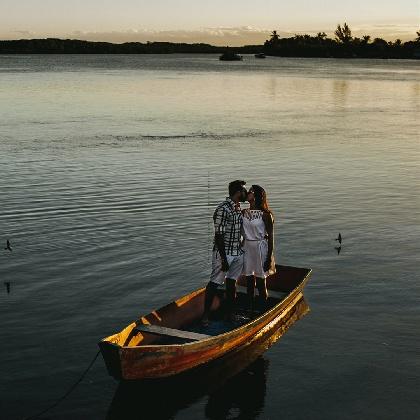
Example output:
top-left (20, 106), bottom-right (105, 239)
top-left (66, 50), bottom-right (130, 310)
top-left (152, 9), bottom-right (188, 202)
top-left (99, 266), bottom-right (311, 379)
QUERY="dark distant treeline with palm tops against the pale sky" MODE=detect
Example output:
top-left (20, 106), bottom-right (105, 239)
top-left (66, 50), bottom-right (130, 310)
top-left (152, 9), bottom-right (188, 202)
top-left (0, 23), bottom-right (420, 59)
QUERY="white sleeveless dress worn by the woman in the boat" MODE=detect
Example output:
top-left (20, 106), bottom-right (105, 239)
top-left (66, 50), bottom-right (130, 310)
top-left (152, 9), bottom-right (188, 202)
top-left (242, 209), bottom-right (274, 278)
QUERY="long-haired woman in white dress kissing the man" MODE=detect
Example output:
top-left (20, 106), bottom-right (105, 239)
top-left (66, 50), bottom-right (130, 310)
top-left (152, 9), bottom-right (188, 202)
top-left (243, 185), bottom-right (276, 309)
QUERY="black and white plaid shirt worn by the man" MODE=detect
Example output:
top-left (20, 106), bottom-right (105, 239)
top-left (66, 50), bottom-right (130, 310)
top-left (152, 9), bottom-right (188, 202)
top-left (213, 197), bottom-right (243, 256)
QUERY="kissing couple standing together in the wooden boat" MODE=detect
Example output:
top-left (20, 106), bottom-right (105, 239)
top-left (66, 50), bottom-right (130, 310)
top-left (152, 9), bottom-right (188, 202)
top-left (202, 180), bottom-right (275, 325)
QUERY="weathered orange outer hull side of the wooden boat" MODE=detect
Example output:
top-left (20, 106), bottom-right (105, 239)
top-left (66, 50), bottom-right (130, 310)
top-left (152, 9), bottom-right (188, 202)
top-left (99, 270), bottom-right (310, 380)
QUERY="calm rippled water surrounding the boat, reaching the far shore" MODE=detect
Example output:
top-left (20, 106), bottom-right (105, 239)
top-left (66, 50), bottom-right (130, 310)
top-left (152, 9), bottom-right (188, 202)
top-left (0, 55), bottom-right (420, 420)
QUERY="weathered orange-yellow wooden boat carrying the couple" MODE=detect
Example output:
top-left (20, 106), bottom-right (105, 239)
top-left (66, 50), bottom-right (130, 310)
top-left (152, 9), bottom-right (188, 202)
top-left (99, 265), bottom-right (311, 380)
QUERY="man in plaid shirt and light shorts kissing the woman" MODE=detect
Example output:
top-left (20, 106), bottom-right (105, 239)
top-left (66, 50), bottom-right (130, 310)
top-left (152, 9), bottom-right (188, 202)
top-left (203, 180), bottom-right (247, 324)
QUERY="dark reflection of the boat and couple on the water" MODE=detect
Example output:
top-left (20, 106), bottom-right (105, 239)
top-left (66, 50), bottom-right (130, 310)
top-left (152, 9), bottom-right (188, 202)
top-left (107, 296), bottom-right (309, 420)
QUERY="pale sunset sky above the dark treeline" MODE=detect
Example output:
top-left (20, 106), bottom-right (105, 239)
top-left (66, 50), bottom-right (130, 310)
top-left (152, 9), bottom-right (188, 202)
top-left (0, 0), bottom-right (420, 45)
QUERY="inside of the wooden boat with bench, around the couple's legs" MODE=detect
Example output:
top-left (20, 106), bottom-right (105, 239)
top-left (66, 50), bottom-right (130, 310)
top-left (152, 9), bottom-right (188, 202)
top-left (103, 265), bottom-right (310, 347)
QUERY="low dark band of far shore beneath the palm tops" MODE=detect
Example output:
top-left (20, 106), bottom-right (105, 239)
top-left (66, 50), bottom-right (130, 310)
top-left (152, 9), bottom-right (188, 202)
top-left (0, 38), bottom-right (420, 60)
